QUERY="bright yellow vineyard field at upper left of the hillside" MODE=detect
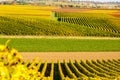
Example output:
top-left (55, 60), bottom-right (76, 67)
top-left (0, 5), bottom-right (56, 19)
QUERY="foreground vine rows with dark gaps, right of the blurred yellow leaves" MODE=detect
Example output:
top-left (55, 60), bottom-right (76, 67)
top-left (23, 59), bottom-right (120, 80)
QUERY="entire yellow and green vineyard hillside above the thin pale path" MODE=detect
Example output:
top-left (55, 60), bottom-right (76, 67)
top-left (0, 5), bottom-right (120, 37)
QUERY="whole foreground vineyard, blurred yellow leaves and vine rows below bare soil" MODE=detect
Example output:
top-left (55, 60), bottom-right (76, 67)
top-left (0, 41), bottom-right (120, 80)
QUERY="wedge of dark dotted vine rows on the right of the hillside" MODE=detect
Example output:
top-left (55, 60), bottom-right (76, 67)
top-left (58, 17), bottom-right (120, 33)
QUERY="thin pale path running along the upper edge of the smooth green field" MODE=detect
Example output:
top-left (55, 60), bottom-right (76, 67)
top-left (0, 35), bottom-right (120, 40)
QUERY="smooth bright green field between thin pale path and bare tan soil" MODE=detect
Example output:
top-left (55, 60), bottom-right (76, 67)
top-left (0, 38), bottom-right (120, 52)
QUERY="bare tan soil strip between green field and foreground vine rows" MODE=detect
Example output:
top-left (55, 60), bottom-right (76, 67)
top-left (20, 52), bottom-right (120, 62)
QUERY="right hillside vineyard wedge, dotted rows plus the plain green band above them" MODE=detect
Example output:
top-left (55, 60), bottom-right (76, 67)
top-left (54, 12), bottom-right (120, 36)
